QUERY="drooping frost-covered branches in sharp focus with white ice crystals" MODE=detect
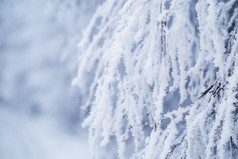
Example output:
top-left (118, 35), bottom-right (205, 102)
top-left (73, 0), bottom-right (238, 159)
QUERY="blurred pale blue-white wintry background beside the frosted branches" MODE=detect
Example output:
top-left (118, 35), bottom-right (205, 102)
top-left (0, 0), bottom-right (102, 159)
